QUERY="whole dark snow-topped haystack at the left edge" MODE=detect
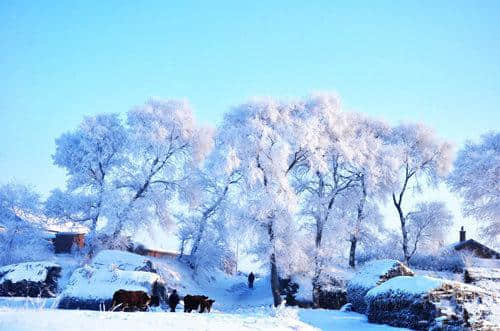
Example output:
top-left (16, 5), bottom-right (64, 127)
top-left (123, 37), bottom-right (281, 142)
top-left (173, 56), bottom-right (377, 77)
top-left (0, 261), bottom-right (61, 298)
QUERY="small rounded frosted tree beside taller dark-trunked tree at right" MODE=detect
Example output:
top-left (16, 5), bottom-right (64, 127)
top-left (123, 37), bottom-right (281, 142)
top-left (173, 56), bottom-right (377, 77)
top-left (405, 201), bottom-right (453, 261)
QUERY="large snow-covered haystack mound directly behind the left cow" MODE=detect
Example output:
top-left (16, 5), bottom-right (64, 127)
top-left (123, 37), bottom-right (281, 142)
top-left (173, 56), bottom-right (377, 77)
top-left (59, 250), bottom-right (166, 310)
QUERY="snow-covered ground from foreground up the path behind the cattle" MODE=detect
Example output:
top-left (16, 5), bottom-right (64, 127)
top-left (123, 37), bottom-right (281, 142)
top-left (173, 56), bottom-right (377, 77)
top-left (0, 256), bottom-right (408, 331)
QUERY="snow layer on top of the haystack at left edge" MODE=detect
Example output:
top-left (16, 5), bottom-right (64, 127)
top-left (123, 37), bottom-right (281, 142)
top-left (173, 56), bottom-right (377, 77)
top-left (0, 261), bottom-right (59, 283)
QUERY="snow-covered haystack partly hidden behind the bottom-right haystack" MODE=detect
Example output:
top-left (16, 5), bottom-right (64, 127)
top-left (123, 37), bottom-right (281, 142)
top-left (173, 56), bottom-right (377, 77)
top-left (347, 260), bottom-right (414, 313)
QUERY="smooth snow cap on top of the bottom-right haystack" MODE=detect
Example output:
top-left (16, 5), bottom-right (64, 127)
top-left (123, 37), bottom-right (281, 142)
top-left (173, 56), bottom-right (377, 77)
top-left (365, 276), bottom-right (445, 298)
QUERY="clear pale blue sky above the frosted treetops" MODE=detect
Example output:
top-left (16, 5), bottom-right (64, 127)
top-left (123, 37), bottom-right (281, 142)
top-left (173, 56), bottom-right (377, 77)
top-left (0, 0), bottom-right (500, 243)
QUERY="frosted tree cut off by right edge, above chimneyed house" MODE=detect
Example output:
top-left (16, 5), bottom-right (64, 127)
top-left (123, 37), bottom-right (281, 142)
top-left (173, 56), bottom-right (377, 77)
top-left (448, 132), bottom-right (500, 239)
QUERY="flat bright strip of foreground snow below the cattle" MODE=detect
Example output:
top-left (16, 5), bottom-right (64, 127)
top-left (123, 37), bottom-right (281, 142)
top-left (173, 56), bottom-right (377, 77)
top-left (0, 301), bottom-right (403, 331)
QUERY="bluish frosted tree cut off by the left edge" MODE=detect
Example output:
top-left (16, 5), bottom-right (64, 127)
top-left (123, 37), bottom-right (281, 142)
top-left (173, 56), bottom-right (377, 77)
top-left (0, 184), bottom-right (52, 265)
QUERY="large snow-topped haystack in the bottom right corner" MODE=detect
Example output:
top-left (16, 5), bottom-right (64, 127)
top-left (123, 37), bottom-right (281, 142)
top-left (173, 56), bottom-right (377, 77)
top-left (365, 276), bottom-right (500, 330)
